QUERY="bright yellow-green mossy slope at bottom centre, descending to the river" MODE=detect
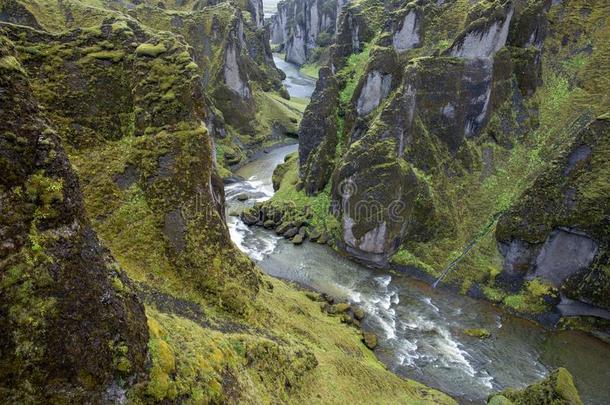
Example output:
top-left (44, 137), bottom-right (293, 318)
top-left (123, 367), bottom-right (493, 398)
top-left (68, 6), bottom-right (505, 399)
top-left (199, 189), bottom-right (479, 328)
top-left (140, 277), bottom-right (454, 404)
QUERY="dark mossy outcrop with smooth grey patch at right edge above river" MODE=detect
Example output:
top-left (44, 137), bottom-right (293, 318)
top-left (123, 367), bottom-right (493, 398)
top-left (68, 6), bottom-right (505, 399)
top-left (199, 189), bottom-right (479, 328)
top-left (496, 114), bottom-right (610, 309)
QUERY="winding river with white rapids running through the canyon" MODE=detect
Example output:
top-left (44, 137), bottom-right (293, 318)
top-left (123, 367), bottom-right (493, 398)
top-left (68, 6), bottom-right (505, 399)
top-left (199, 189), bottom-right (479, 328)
top-left (226, 56), bottom-right (610, 405)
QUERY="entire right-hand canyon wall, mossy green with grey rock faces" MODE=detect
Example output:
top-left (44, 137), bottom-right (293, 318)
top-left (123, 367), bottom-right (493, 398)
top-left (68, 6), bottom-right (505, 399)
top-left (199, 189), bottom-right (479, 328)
top-left (268, 0), bottom-right (610, 332)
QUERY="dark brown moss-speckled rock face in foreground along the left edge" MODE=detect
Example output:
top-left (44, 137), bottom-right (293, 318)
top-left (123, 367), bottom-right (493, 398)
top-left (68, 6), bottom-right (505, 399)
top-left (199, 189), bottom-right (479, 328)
top-left (0, 35), bottom-right (148, 403)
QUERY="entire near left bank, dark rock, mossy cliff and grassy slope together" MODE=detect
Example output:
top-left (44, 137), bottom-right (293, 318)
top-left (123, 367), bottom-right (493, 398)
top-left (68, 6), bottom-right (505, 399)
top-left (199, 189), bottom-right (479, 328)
top-left (0, 5), bottom-right (455, 404)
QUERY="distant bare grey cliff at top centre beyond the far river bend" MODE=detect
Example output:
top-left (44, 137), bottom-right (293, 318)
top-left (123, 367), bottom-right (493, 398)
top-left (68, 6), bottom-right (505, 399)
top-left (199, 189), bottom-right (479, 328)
top-left (271, 0), bottom-right (347, 65)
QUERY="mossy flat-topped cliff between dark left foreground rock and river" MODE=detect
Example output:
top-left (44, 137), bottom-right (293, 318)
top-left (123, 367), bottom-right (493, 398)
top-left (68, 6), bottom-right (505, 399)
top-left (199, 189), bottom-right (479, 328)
top-left (4, 21), bottom-right (257, 311)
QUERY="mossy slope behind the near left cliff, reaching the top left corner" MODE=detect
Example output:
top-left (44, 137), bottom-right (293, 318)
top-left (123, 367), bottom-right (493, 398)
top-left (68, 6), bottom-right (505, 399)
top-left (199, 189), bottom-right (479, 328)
top-left (0, 0), bottom-right (300, 175)
